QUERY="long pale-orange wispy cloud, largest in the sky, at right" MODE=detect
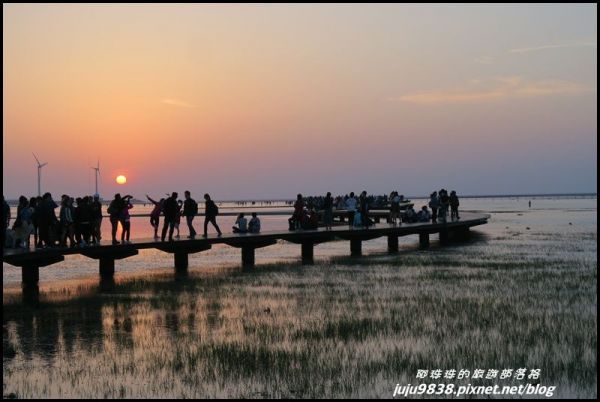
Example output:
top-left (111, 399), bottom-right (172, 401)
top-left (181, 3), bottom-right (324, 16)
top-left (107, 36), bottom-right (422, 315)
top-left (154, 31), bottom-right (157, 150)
top-left (388, 76), bottom-right (593, 104)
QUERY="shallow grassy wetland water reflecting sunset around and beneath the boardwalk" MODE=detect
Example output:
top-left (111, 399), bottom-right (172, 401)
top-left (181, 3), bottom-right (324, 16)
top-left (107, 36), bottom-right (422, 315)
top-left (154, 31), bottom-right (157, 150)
top-left (3, 198), bottom-right (597, 398)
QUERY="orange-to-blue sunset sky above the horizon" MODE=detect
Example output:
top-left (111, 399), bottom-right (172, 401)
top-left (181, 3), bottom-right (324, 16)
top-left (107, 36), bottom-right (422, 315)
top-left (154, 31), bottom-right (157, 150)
top-left (3, 4), bottom-right (597, 199)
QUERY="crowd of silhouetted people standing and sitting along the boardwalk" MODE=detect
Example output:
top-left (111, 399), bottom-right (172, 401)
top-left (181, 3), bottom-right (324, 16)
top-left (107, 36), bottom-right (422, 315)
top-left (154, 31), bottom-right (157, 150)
top-left (3, 189), bottom-right (460, 248)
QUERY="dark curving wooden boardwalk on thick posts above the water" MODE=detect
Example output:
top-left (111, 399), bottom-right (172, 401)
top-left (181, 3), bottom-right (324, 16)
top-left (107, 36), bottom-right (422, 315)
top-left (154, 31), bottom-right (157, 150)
top-left (2, 212), bottom-right (490, 286)
